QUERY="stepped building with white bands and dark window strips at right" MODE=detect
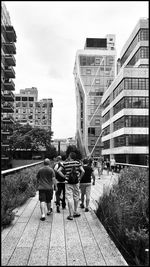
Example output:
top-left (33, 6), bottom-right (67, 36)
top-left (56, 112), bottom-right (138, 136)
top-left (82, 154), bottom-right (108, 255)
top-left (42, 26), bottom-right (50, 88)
top-left (102, 19), bottom-right (149, 165)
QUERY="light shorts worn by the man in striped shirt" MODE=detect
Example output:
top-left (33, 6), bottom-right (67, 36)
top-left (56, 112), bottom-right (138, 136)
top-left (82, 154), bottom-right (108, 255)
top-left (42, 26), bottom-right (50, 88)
top-left (65, 184), bottom-right (80, 202)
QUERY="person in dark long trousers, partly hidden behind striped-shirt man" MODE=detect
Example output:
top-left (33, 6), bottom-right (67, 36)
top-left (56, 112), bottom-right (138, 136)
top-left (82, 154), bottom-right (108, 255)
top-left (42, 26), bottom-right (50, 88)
top-left (54, 156), bottom-right (66, 213)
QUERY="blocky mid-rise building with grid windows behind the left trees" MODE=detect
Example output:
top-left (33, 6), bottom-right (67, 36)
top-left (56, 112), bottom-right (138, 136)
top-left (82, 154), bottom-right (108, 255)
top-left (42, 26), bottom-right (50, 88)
top-left (14, 87), bottom-right (53, 130)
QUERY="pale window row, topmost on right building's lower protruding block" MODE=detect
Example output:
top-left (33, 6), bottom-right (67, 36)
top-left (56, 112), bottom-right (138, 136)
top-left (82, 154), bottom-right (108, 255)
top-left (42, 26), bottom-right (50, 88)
top-left (113, 78), bottom-right (149, 99)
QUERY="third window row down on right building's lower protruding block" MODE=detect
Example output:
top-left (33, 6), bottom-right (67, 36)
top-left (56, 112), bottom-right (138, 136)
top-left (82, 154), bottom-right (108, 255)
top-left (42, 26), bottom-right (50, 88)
top-left (114, 115), bottom-right (149, 131)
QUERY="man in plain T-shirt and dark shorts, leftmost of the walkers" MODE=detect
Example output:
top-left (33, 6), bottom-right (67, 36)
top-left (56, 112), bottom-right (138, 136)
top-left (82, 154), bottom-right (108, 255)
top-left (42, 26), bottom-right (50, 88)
top-left (37, 158), bottom-right (57, 221)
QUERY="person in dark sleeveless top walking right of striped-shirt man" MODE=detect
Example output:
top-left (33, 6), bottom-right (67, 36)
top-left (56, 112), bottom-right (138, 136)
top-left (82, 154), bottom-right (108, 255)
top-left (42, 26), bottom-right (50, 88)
top-left (80, 159), bottom-right (95, 212)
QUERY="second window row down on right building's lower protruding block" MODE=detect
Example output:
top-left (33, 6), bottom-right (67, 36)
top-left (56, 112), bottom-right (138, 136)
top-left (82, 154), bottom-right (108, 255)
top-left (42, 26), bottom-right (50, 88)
top-left (113, 96), bottom-right (149, 116)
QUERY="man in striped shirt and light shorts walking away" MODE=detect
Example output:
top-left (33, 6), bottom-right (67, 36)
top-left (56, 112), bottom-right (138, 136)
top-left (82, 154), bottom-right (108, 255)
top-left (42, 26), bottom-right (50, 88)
top-left (58, 152), bottom-right (85, 220)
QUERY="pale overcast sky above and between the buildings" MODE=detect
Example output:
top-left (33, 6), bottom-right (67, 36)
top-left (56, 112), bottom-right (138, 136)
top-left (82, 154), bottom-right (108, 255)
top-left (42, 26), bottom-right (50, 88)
top-left (3, 1), bottom-right (148, 138)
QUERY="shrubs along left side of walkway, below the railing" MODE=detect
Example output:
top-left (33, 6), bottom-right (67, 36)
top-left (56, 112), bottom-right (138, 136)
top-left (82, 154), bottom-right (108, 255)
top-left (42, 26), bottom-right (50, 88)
top-left (1, 164), bottom-right (41, 227)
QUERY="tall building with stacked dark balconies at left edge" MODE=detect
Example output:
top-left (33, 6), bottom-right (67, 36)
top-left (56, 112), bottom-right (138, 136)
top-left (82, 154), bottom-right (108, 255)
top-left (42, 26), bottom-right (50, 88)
top-left (1, 3), bottom-right (16, 169)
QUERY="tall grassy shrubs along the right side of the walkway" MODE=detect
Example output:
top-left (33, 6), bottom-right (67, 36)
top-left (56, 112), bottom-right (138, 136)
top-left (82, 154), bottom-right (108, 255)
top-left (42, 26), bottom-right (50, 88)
top-left (97, 167), bottom-right (149, 265)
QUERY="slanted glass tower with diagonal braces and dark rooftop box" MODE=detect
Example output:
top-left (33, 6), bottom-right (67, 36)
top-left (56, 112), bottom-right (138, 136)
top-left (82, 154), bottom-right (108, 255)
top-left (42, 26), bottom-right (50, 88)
top-left (74, 34), bottom-right (116, 157)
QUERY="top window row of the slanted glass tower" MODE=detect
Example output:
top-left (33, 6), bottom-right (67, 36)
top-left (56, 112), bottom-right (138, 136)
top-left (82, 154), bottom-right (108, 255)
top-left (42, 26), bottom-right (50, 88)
top-left (80, 56), bottom-right (114, 66)
